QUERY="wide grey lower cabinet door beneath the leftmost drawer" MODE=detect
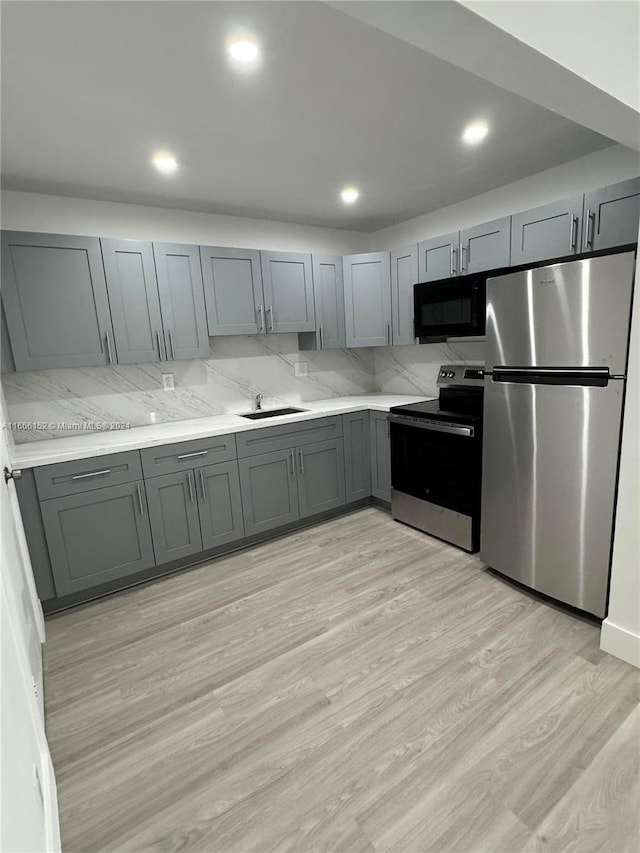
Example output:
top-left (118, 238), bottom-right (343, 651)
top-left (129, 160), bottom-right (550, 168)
top-left (40, 480), bottom-right (154, 596)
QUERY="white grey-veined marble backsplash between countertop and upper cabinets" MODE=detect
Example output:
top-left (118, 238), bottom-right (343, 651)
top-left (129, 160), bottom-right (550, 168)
top-left (2, 335), bottom-right (483, 444)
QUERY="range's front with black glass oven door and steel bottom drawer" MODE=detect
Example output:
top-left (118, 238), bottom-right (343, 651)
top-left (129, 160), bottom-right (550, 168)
top-left (389, 415), bottom-right (482, 551)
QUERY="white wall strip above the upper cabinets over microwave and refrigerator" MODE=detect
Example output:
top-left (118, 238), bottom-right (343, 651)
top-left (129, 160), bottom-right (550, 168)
top-left (369, 145), bottom-right (640, 250)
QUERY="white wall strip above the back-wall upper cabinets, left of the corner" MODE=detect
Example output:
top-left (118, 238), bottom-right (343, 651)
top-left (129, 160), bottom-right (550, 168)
top-left (1, 190), bottom-right (367, 255)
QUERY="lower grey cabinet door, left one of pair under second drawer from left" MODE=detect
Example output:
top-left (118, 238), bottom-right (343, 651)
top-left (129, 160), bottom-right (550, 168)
top-left (145, 471), bottom-right (202, 566)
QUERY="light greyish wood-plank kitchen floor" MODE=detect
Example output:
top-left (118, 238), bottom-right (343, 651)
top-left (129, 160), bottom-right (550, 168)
top-left (45, 508), bottom-right (640, 853)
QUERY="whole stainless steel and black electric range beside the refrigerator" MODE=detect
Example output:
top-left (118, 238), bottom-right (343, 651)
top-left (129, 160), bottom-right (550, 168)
top-left (389, 364), bottom-right (484, 551)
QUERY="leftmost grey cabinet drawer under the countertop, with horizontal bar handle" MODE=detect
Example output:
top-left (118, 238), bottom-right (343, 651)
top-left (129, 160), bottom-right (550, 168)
top-left (34, 450), bottom-right (142, 501)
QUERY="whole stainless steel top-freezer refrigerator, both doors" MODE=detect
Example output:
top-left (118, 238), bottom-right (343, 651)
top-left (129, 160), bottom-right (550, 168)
top-left (480, 252), bottom-right (635, 617)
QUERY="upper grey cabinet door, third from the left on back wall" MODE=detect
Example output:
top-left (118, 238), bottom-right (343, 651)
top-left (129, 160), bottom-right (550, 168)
top-left (153, 243), bottom-right (209, 360)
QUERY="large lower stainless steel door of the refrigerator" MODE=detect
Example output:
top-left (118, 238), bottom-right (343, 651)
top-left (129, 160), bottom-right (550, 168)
top-left (480, 380), bottom-right (624, 617)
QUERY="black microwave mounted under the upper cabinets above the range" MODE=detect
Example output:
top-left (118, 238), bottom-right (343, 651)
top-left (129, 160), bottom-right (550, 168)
top-left (413, 275), bottom-right (487, 343)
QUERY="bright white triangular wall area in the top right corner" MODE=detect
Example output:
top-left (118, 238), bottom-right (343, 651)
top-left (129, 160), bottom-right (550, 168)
top-left (461, 0), bottom-right (640, 111)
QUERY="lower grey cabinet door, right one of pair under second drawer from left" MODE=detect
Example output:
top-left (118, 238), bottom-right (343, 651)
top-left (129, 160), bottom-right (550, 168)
top-left (195, 459), bottom-right (244, 550)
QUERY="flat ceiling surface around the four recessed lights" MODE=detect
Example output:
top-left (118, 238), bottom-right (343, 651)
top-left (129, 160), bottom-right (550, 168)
top-left (2, 0), bottom-right (611, 231)
